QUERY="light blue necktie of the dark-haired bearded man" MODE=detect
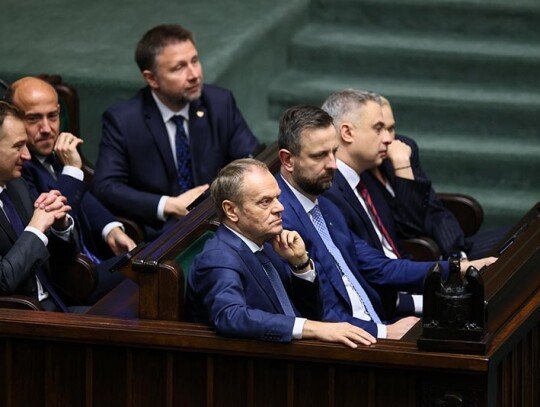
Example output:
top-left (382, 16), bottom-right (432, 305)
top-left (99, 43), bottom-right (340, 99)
top-left (309, 205), bottom-right (381, 324)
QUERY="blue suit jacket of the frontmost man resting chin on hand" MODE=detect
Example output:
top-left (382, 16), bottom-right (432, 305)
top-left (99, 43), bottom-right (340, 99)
top-left (186, 226), bottom-right (319, 342)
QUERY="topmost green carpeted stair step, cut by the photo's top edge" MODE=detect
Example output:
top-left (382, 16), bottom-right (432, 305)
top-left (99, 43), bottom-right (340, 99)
top-left (312, 0), bottom-right (540, 39)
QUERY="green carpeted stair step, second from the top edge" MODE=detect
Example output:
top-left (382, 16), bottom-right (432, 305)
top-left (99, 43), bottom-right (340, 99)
top-left (289, 23), bottom-right (540, 90)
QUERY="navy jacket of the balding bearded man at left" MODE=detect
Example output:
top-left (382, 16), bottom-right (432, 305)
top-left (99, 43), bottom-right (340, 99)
top-left (22, 156), bottom-right (116, 257)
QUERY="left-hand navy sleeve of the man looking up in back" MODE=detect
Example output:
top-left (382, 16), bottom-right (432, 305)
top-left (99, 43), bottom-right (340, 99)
top-left (94, 111), bottom-right (161, 227)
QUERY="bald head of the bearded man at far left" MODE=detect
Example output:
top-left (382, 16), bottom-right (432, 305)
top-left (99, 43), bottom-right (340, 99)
top-left (6, 76), bottom-right (60, 156)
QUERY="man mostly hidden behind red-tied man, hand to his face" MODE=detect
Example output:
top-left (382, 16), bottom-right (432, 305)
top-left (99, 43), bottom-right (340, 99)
top-left (368, 96), bottom-right (510, 260)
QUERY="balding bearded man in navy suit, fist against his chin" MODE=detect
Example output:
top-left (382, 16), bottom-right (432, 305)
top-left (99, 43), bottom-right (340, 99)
top-left (8, 77), bottom-right (135, 304)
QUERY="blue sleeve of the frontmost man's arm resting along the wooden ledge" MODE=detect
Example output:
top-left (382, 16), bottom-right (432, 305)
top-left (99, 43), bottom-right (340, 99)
top-left (190, 250), bottom-right (295, 342)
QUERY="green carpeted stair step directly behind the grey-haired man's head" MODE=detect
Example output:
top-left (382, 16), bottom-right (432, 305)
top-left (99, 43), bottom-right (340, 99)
top-left (269, 71), bottom-right (540, 143)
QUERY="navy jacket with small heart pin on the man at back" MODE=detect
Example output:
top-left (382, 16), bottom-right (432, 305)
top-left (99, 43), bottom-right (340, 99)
top-left (94, 85), bottom-right (259, 239)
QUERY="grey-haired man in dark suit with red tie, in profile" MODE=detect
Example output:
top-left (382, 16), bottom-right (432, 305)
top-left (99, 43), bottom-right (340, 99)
top-left (322, 89), bottom-right (407, 259)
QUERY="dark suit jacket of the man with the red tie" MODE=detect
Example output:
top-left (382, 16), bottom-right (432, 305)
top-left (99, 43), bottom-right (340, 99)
top-left (324, 170), bottom-right (407, 257)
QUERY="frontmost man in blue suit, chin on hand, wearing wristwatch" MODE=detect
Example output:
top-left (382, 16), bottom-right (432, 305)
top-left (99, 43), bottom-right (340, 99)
top-left (186, 159), bottom-right (375, 348)
